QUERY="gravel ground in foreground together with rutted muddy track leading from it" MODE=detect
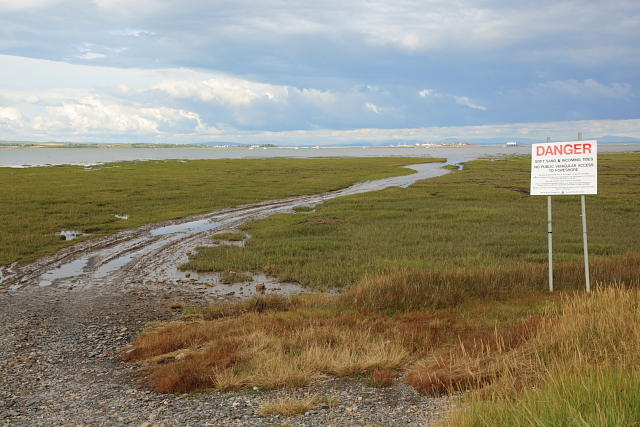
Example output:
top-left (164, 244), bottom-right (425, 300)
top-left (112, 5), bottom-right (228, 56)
top-left (0, 163), bottom-right (460, 427)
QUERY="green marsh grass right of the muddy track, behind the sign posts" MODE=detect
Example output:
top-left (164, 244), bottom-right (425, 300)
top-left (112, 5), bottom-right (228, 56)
top-left (182, 153), bottom-right (640, 289)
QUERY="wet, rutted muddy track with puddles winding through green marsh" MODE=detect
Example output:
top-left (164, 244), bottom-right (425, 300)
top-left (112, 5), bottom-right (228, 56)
top-left (0, 163), bottom-right (447, 300)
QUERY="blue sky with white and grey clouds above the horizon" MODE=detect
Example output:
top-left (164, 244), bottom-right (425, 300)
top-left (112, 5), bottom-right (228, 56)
top-left (0, 0), bottom-right (640, 145)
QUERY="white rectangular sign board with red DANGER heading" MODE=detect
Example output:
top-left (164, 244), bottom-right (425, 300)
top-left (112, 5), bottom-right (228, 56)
top-left (530, 140), bottom-right (598, 196)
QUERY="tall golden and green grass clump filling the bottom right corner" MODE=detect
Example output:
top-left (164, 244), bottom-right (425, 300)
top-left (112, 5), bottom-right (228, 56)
top-left (442, 282), bottom-right (640, 427)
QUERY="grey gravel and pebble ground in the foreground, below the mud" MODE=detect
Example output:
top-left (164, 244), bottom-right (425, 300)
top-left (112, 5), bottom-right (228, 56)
top-left (0, 268), bottom-right (458, 427)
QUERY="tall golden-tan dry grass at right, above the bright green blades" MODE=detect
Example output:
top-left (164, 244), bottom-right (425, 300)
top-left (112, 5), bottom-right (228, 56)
top-left (408, 282), bottom-right (640, 402)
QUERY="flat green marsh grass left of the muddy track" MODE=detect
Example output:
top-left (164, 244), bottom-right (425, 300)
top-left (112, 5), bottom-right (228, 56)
top-left (0, 158), bottom-right (441, 265)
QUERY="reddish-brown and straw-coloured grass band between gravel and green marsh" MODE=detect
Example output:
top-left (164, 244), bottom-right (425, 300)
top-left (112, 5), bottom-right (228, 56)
top-left (124, 264), bottom-right (637, 394)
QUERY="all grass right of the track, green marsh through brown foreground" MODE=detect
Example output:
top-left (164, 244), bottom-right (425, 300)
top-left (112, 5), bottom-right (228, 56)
top-left (126, 153), bottom-right (640, 427)
